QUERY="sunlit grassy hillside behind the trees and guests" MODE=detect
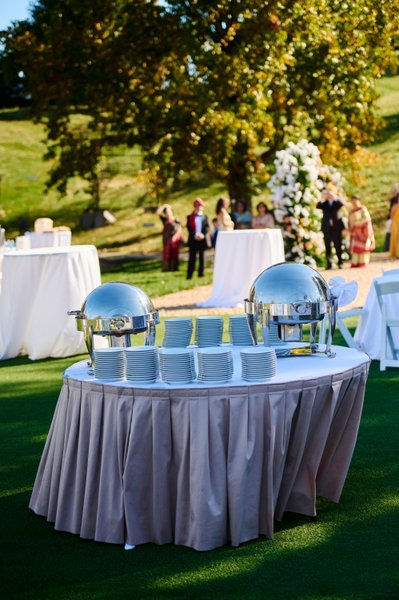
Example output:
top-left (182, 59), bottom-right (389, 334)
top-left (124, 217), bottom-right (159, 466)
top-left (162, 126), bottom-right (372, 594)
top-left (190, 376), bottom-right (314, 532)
top-left (0, 75), bottom-right (399, 254)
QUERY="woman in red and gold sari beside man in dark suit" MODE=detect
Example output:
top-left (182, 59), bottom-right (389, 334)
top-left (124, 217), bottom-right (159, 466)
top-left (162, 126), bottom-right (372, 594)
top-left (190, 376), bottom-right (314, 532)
top-left (348, 195), bottom-right (375, 267)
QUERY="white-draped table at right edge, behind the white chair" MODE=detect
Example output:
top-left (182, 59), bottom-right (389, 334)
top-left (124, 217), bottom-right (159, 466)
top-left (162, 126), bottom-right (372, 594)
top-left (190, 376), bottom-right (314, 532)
top-left (353, 274), bottom-right (399, 360)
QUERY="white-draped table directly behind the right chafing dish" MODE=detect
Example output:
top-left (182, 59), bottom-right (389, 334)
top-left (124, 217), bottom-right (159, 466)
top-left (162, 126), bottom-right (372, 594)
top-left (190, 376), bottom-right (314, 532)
top-left (197, 229), bottom-right (285, 307)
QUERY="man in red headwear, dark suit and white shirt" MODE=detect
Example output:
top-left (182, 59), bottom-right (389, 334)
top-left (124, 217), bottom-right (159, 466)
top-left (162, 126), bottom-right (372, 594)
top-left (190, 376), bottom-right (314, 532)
top-left (187, 198), bottom-right (209, 279)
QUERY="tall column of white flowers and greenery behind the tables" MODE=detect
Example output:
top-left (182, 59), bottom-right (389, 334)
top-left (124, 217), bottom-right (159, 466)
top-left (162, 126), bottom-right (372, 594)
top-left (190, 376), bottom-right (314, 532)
top-left (268, 140), bottom-right (343, 267)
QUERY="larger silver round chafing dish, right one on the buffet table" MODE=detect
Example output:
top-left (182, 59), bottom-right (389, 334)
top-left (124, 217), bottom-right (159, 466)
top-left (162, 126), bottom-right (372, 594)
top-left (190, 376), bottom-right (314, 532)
top-left (244, 263), bottom-right (336, 356)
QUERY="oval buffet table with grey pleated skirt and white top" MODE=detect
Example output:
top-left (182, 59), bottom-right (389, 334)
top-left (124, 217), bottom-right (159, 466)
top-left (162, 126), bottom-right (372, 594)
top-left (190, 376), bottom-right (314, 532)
top-left (29, 347), bottom-right (369, 550)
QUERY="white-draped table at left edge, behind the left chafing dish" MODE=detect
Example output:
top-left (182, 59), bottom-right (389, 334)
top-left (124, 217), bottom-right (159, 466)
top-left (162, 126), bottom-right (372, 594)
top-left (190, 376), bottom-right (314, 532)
top-left (0, 245), bottom-right (101, 360)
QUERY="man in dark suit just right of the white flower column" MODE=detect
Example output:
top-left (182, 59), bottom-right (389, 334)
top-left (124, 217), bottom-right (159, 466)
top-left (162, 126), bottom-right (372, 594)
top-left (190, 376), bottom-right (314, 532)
top-left (317, 189), bottom-right (345, 269)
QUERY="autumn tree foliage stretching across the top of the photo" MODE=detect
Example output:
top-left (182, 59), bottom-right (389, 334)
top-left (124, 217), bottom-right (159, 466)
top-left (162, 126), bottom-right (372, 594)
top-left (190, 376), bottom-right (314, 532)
top-left (2, 0), bottom-right (399, 206)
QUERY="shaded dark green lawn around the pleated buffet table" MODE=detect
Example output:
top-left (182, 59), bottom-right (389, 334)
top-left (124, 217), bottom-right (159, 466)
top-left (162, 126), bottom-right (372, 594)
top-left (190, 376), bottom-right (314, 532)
top-left (0, 328), bottom-right (399, 600)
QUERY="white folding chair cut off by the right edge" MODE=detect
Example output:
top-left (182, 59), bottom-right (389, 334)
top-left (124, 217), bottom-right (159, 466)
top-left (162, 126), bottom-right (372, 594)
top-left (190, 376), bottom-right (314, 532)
top-left (374, 280), bottom-right (399, 371)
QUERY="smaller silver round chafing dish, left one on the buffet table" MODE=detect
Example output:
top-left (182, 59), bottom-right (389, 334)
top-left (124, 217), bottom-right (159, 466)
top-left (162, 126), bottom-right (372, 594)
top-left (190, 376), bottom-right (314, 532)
top-left (68, 281), bottom-right (159, 365)
